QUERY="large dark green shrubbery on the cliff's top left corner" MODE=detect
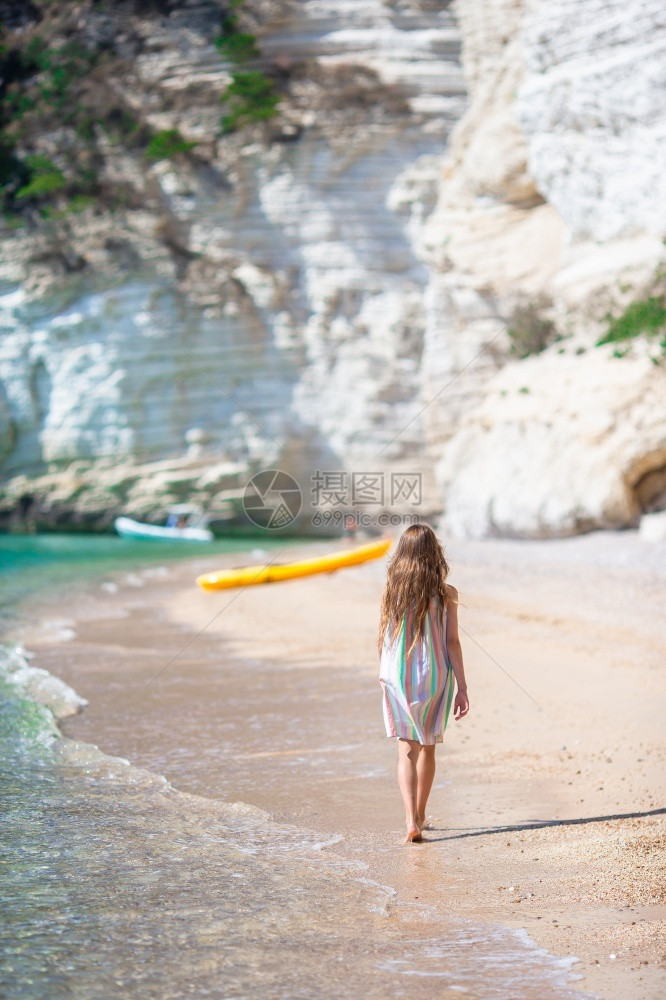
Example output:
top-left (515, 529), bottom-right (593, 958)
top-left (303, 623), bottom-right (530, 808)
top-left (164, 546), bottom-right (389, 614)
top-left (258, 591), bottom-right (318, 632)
top-left (0, 14), bottom-right (150, 221)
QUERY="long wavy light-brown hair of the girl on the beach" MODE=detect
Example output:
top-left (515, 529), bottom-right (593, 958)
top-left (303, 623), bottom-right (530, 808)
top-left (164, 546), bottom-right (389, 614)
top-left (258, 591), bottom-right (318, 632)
top-left (377, 524), bottom-right (451, 656)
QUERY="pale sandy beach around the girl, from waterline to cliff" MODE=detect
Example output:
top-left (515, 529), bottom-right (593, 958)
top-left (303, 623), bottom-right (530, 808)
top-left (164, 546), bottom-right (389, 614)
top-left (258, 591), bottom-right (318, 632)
top-left (16, 533), bottom-right (666, 1000)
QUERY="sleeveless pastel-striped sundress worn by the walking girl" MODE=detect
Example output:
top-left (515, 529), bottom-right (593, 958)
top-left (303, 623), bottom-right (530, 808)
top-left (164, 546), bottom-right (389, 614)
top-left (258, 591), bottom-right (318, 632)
top-left (379, 597), bottom-right (454, 745)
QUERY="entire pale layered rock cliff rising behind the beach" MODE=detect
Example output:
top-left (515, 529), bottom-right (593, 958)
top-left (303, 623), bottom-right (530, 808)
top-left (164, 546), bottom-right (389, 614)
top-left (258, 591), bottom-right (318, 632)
top-left (0, 0), bottom-right (666, 535)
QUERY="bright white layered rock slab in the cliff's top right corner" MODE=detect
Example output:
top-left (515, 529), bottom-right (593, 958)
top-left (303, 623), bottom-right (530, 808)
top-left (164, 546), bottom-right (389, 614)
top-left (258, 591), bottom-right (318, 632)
top-left (515, 0), bottom-right (666, 241)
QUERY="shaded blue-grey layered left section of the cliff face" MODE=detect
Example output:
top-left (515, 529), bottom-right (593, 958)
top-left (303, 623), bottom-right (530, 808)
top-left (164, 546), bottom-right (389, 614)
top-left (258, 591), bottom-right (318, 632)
top-left (0, 0), bottom-right (465, 532)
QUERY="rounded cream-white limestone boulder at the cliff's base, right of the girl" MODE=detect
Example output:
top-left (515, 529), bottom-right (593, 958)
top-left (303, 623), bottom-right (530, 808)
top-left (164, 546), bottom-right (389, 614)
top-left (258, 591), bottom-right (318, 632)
top-left (437, 349), bottom-right (666, 538)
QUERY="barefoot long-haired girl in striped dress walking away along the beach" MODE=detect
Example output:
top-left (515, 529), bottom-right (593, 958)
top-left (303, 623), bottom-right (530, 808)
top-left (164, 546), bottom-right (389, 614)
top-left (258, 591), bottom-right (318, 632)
top-left (378, 524), bottom-right (469, 844)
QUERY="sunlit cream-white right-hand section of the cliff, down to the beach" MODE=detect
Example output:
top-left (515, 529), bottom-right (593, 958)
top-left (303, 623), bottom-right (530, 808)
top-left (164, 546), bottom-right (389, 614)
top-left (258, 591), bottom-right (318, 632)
top-left (425, 0), bottom-right (666, 537)
